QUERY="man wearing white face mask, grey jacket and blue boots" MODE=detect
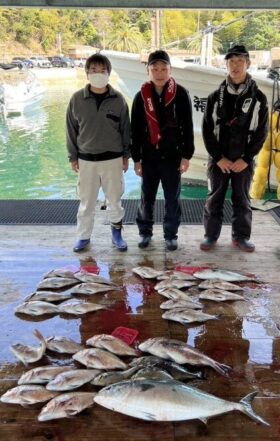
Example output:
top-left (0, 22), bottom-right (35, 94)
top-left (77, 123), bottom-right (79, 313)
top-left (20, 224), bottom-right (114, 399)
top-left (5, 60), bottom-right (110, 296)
top-left (66, 54), bottom-right (130, 252)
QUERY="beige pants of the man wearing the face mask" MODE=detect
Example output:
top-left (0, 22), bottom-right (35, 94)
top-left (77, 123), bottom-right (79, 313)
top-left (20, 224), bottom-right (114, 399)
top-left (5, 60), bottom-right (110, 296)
top-left (77, 157), bottom-right (124, 240)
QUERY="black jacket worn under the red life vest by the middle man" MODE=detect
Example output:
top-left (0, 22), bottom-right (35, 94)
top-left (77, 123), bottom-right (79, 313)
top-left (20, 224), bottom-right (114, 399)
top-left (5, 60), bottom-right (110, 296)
top-left (131, 84), bottom-right (194, 162)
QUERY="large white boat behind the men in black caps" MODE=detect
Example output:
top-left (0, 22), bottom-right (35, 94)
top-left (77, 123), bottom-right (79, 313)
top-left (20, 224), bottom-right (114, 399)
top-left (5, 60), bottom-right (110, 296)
top-left (102, 50), bottom-right (277, 185)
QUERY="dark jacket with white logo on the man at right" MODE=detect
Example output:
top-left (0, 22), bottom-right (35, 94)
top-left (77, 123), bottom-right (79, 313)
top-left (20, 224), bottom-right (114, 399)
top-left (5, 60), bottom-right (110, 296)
top-left (202, 75), bottom-right (268, 164)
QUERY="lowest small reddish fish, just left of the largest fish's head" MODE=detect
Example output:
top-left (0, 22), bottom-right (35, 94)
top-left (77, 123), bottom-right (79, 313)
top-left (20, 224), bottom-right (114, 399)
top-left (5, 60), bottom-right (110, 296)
top-left (38, 392), bottom-right (95, 421)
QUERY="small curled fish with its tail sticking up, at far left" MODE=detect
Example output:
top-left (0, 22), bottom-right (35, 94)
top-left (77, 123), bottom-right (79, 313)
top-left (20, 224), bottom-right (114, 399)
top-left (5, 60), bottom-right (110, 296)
top-left (10, 329), bottom-right (47, 365)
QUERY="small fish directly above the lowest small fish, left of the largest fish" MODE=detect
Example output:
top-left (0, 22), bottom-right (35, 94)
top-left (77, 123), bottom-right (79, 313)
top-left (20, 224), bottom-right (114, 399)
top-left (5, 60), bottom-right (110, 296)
top-left (46, 369), bottom-right (101, 391)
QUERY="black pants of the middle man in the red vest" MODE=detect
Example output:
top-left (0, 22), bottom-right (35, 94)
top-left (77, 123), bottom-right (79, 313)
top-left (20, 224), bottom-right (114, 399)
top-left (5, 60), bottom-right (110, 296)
top-left (136, 155), bottom-right (181, 239)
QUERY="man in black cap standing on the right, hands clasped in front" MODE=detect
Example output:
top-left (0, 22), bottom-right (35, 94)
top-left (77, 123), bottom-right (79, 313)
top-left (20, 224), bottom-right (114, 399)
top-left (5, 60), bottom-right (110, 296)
top-left (200, 45), bottom-right (268, 252)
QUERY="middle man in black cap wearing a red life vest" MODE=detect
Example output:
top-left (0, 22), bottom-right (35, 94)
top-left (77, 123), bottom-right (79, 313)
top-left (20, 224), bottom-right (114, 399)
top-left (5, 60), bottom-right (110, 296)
top-left (131, 50), bottom-right (194, 251)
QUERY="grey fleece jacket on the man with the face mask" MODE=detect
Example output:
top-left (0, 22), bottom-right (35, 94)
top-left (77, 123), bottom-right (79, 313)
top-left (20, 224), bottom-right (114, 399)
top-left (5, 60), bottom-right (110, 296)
top-left (66, 85), bottom-right (130, 161)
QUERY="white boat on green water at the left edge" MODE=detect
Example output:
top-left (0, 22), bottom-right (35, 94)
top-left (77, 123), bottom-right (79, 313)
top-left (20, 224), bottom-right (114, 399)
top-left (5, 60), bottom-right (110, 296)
top-left (0, 63), bottom-right (45, 117)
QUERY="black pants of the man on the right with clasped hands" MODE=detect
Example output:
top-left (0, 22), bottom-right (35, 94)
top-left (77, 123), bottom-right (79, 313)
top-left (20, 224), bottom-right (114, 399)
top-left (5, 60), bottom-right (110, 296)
top-left (203, 160), bottom-right (253, 240)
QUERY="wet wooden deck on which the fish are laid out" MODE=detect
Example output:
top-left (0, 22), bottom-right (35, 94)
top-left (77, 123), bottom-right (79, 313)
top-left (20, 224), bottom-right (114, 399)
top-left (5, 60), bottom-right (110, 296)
top-left (0, 207), bottom-right (280, 441)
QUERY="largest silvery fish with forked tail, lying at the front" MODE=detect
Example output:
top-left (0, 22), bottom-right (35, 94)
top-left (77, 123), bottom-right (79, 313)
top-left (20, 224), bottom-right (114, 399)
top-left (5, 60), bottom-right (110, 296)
top-left (94, 380), bottom-right (269, 426)
